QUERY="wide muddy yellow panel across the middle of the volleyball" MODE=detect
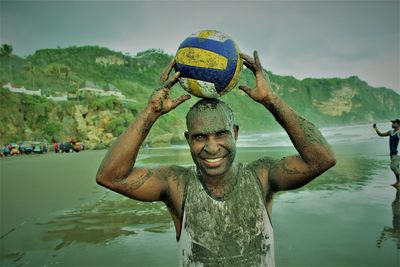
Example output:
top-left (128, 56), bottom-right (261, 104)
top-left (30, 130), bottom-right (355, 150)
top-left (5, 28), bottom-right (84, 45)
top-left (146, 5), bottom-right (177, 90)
top-left (176, 47), bottom-right (228, 70)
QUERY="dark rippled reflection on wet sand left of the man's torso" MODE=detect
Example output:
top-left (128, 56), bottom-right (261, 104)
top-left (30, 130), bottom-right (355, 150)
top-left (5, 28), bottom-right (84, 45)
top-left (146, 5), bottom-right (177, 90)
top-left (38, 197), bottom-right (172, 250)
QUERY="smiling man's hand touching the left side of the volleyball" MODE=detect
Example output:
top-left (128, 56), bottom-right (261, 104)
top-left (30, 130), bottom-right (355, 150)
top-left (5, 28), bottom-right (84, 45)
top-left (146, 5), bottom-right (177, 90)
top-left (147, 60), bottom-right (190, 120)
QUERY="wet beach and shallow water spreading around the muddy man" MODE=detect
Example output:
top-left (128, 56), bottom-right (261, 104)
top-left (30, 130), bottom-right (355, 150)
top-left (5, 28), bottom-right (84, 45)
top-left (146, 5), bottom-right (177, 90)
top-left (0, 124), bottom-right (400, 267)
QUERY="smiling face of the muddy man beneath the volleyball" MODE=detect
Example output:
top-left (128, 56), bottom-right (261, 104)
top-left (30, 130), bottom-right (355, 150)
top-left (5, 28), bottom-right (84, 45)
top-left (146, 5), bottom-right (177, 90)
top-left (185, 107), bottom-right (238, 178)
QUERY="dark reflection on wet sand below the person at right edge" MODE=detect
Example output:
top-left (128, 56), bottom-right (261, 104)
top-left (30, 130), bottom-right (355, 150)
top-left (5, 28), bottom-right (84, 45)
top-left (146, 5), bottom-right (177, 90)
top-left (376, 190), bottom-right (400, 250)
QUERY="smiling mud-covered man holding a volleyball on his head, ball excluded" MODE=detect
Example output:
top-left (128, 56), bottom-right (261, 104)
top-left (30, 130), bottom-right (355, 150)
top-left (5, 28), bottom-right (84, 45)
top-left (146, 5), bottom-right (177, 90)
top-left (96, 52), bottom-right (335, 266)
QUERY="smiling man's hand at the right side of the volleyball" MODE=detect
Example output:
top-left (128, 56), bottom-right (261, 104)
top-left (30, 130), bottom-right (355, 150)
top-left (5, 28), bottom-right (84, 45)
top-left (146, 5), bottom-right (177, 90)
top-left (239, 51), bottom-right (274, 104)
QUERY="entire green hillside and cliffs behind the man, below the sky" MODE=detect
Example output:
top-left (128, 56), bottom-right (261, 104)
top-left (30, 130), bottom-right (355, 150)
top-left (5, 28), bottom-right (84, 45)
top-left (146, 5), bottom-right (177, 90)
top-left (0, 46), bottom-right (400, 147)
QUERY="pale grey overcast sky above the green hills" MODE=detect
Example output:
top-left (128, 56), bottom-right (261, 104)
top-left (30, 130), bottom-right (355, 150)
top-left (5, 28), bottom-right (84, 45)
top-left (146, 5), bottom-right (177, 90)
top-left (0, 0), bottom-right (400, 93)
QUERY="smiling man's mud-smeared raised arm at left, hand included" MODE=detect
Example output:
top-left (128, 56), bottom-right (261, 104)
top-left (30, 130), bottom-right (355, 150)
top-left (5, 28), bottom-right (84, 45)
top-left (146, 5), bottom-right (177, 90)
top-left (96, 61), bottom-right (190, 201)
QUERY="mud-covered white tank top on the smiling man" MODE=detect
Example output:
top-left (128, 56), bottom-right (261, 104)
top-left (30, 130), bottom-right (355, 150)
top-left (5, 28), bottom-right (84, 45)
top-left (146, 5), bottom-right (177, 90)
top-left (178, 164), bottom-right (275, 267)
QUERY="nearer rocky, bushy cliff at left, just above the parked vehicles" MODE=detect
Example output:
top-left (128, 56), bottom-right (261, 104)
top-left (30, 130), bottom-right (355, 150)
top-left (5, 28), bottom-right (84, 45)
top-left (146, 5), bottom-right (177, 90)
top-left (0, 89), bottom-right (135, 148)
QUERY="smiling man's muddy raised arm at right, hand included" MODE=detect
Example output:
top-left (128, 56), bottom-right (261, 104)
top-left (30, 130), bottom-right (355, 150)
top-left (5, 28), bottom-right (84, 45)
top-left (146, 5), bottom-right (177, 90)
top-left (239, 51), bottom-right (336, 191)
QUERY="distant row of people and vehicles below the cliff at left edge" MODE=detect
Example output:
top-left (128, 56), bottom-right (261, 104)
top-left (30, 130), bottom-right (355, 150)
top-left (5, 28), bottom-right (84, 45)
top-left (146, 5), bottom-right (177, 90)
top-left (0, 140), bottom-right (85, 157)
